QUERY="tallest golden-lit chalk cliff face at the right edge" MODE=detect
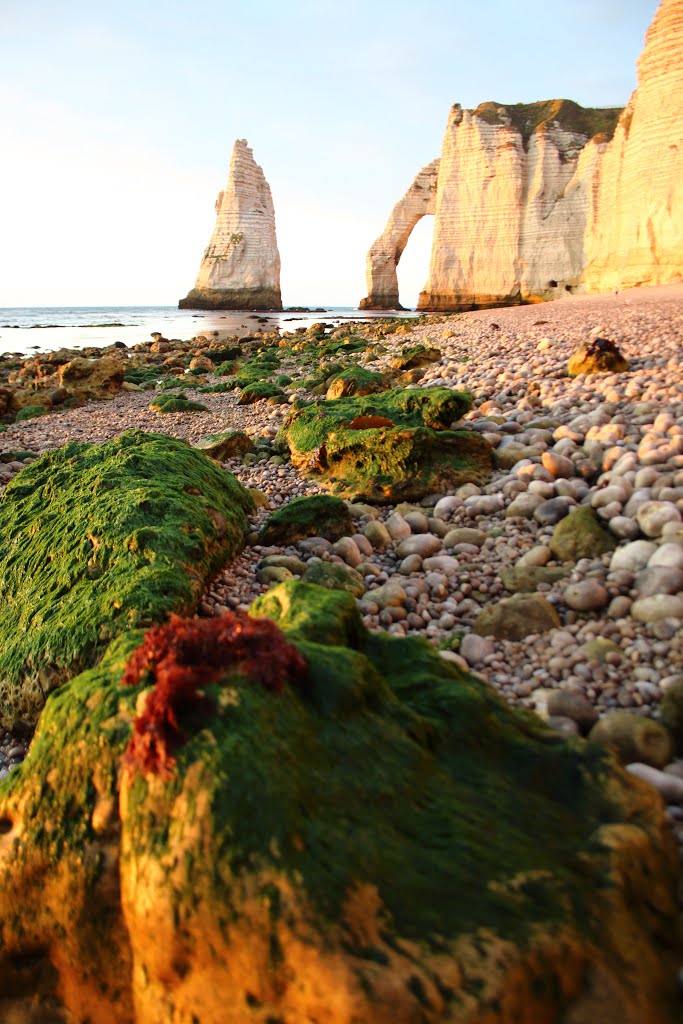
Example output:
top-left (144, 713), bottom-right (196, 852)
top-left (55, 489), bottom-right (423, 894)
top-left (582, 0), bottom-right (683, 292)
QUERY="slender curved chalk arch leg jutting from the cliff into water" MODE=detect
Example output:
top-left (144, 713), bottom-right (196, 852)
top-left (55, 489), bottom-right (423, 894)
top-left (359, 159), bottom-right (439, 309)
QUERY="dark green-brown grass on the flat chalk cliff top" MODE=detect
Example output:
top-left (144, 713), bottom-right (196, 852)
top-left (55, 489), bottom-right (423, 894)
top-left (474, 99), bottom-right (623, 145)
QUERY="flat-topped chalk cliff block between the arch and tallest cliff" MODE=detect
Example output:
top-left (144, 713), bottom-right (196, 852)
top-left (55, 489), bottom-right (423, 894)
top-left (419, 99), bottom-right (620, 309)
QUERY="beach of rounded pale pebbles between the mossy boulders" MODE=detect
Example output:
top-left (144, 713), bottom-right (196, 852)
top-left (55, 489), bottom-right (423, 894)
top-left (0, 286), bottom-right (683, 913)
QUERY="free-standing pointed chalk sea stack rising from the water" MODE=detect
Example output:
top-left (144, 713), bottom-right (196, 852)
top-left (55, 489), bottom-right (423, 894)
top-left (179, 139), bottom-right (283, 309)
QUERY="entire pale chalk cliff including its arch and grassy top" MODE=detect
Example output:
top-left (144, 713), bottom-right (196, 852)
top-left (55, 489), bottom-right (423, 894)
top-left (360, 0), bottom-right (683, 310)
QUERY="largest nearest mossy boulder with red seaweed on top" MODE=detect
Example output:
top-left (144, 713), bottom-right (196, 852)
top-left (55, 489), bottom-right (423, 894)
top-left (0, 582), bottom-right (678, 1024)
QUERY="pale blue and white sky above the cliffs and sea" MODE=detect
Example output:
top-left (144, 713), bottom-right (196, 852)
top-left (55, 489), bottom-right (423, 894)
top-left (0, 0), bottom-right (657, 307)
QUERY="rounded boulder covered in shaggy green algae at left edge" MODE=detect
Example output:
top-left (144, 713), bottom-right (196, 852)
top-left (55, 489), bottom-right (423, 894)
top-left (0, 431), bottom-right (254, 726)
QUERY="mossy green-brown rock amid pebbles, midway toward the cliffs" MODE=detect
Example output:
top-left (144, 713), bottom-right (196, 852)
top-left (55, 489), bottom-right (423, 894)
top-left (279, 388), bottom-right (492, 503)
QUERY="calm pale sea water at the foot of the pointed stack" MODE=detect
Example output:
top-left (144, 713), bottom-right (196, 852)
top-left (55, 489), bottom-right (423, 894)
top-left (0, 306), bottom-right (417, 355)
